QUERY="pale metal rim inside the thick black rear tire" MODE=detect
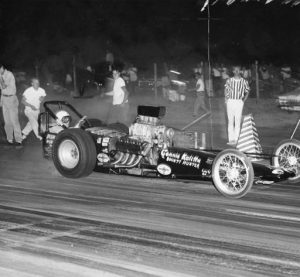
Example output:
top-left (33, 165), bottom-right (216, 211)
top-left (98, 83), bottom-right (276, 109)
top-left (58, 140), bottom-right (79, 169)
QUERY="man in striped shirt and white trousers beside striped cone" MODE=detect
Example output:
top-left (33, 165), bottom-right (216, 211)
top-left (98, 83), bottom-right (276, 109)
top-left (225, 66), bottom-right (250, 145)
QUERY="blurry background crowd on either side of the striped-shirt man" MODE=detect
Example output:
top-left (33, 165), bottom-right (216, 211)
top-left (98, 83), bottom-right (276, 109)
top-left (159, 62), bottom-right (300, 98)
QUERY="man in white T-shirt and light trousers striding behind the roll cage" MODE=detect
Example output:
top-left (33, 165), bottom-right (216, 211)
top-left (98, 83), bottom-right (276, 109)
top-left (22, 78), bottom-right (46, 140)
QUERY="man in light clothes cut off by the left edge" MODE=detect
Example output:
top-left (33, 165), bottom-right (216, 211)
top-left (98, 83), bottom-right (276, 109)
top-left (0, 64), bottom-right (22, 145)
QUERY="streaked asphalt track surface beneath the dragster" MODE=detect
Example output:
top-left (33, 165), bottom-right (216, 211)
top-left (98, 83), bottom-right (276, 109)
top-left (0, 143), bottom-right (300, 277)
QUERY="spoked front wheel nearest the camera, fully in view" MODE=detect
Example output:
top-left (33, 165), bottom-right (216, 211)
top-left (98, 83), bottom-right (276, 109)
top-left (212, 149), bottom-right (254, 198)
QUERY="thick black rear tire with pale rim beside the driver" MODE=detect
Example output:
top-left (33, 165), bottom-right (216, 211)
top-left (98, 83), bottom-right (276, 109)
top-left (52, 129), bottom-right (97, 178)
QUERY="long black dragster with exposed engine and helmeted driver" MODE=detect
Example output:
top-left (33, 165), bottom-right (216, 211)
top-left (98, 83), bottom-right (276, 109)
top-left (39, 101), bottom-right (300, 198)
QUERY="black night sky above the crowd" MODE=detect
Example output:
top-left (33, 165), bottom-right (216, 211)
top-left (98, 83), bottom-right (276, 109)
top-left (0, 0), bottom-right (300, 67)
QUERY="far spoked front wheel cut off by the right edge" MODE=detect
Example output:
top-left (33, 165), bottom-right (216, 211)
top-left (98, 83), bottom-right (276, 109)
top-left (273, 139), bottom-right (300, 183)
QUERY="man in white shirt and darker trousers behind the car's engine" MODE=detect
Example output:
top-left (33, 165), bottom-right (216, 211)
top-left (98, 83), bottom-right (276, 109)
top-left (105, 69), bottom-right (129, 124)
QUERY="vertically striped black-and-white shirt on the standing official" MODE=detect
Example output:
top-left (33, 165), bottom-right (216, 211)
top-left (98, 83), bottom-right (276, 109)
top-left (225, 77), bottom-right (250, 99)
